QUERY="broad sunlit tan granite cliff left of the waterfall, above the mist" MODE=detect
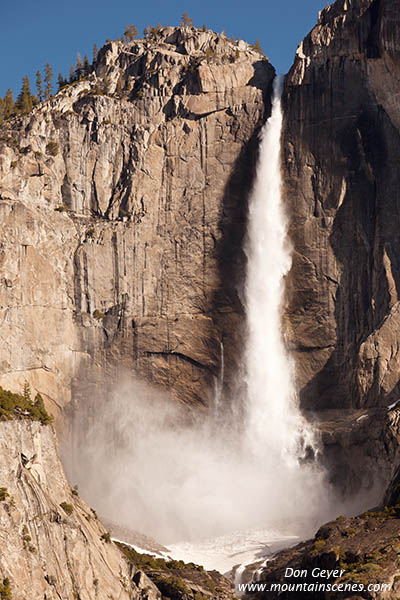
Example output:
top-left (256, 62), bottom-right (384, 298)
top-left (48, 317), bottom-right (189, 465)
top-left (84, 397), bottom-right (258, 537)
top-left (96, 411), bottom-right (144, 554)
top-left (0, 27), bottom-right (274, 412)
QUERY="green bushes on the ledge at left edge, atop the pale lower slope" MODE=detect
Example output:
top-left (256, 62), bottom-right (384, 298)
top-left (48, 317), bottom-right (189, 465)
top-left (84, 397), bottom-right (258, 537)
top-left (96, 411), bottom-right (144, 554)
top-left (0, 383), bottom-right (53, 425)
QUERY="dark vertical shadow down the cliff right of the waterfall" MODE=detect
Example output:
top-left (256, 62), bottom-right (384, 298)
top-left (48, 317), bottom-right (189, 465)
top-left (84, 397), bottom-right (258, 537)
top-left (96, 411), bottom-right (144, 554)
top-left (302, 98), bottom-right (400, 409)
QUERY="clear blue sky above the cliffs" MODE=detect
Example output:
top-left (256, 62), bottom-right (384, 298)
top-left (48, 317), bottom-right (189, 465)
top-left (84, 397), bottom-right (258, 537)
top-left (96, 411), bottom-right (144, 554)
top-left (0, 0), bottom-right (332, 96)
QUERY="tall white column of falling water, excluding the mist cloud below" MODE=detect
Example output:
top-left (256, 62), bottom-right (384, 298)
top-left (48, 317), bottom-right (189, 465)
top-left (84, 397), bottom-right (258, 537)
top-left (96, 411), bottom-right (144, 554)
top-left (245, 76), bottom-right (312, 462)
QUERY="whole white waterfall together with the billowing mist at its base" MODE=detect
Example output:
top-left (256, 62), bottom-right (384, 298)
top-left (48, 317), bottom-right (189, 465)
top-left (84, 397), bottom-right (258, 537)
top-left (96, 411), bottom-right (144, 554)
top-left (64, 78), bottom-right (332, 571)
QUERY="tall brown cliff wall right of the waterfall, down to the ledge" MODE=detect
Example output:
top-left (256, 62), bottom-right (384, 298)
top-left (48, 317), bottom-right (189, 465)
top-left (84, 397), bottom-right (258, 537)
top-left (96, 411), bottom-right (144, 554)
top-left (283, 0), bottom-right (400, 409)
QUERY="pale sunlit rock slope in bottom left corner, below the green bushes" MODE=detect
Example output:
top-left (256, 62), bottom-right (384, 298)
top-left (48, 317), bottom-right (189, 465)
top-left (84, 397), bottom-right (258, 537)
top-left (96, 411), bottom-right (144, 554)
top-left (0, 420), bottom-right (161, 600)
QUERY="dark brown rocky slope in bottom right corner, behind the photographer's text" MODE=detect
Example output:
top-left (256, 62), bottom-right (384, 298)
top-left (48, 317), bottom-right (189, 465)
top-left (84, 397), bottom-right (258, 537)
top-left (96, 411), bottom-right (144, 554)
top-left (244, 496), bottom-right (400, 600)
